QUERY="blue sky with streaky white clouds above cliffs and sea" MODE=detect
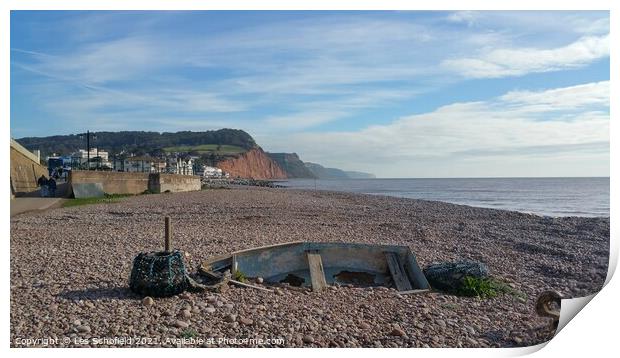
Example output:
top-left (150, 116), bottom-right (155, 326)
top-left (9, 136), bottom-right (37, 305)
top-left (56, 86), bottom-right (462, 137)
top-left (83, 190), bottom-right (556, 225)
top-left (10, 11), bottom-right (610, 178)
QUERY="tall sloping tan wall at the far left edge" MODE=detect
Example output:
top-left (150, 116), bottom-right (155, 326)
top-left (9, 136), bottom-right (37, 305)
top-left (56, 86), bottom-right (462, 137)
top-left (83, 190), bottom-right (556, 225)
top-left (10, 139), bottom-right (48, 196)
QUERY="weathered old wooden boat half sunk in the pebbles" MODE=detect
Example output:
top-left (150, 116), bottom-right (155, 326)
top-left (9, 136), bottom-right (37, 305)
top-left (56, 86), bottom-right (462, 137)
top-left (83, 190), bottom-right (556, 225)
top-left (201, 242), bottom-right (430, 291)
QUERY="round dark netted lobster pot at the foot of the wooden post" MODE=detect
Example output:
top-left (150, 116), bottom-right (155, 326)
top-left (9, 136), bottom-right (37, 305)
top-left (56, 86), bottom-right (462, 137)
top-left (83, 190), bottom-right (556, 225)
top-left (129, 250), bottom-right (188, 297)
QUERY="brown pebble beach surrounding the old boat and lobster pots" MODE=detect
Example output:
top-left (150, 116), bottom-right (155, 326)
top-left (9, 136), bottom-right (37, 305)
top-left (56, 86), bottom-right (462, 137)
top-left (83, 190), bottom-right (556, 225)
top-left (11, 187), bottom-right (609, 347)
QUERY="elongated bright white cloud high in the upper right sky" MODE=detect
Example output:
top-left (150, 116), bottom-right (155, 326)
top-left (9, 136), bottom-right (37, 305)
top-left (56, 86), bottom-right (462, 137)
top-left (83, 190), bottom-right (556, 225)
top-left (441, 34), bottom-right (609, 78)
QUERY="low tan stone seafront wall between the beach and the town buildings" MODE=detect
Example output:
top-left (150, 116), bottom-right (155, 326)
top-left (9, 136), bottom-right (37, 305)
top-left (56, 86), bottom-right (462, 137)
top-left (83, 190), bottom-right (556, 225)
top-left (69, 170), bottom-right (201, 194)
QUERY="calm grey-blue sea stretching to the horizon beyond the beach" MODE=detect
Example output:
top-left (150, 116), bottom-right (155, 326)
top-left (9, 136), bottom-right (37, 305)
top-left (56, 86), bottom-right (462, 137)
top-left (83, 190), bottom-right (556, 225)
top-left (282, 178), bottom-right (609, 216)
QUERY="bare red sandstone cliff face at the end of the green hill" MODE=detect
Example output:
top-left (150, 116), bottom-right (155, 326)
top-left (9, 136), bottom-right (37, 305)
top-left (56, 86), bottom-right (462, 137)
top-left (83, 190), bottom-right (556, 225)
top-left (216, 148), bottom-right (286, 179)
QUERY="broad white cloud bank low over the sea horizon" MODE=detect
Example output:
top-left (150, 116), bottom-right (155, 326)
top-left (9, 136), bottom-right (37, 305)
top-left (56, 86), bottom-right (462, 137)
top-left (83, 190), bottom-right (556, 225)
top-left (260, 82), bottom-right (609, 177)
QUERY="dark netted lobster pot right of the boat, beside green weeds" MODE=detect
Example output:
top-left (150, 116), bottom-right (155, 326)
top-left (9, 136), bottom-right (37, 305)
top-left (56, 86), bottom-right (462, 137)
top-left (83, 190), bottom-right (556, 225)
top-left (424, 261), bottom-right (489, 291)
